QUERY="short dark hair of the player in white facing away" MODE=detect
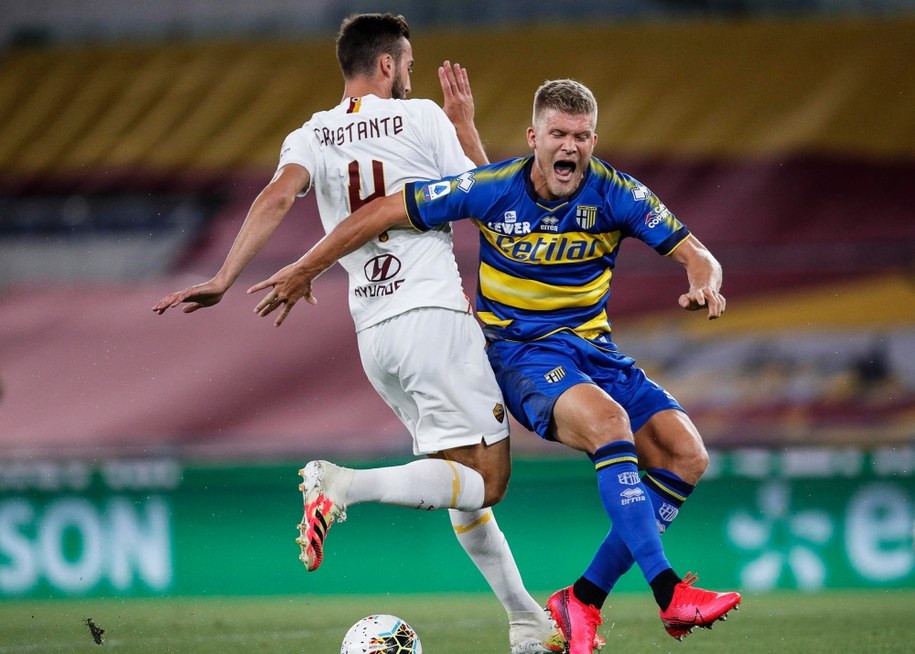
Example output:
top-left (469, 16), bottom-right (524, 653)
top-left (337, 14), bottom-right (410, 79)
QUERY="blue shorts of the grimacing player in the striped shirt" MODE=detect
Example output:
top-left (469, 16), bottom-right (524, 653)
top-left (487, 332), bottom-right (685, 440)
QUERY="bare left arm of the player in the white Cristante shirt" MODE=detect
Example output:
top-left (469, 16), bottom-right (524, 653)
top-left (153, 164), bottom-right (309, 315)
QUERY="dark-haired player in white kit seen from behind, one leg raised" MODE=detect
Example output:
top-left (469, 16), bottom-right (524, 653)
top-left (153, 14), bottom-right (565, 654)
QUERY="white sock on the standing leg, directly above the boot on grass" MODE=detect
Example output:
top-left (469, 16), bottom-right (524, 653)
top-left (448, 509), bottom-right (548, 627)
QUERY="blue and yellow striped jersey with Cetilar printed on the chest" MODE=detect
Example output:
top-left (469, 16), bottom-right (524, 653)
top-left (404, 156), bottom-right (689, 341)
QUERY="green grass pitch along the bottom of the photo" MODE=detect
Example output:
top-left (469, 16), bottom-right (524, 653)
top-left (0, 591), bottom-right (915, 654)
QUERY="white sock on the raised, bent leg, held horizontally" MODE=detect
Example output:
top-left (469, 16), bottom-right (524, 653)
top-left (341, 459), bottom-right (484, 511)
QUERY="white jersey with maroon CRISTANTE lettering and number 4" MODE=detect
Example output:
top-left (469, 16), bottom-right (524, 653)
top-left (279, 95), bottom-right (474, 331)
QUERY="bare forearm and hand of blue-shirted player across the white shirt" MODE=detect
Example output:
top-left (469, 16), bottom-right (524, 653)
top-left (248, 193), bottom-right (410, 327)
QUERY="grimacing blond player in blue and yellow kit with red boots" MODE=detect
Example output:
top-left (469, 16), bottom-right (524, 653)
top-left (251, 80), bottom-right (741, 654)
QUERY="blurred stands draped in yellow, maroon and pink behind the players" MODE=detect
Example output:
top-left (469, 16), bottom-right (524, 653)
top-left (0, 20), bottom-right (915, 455)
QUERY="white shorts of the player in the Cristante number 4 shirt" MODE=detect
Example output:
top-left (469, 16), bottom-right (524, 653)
top-left (357, 307), bottom-right (508, 454)
